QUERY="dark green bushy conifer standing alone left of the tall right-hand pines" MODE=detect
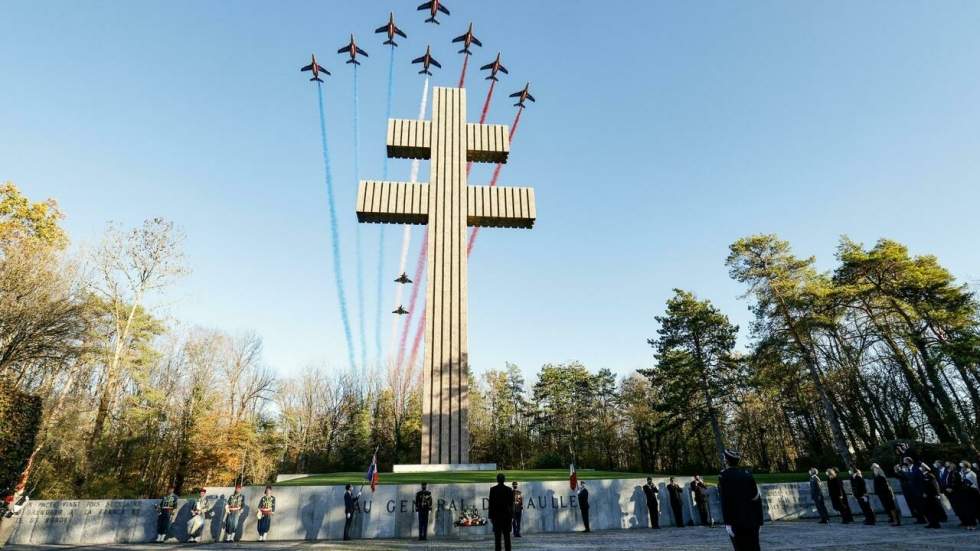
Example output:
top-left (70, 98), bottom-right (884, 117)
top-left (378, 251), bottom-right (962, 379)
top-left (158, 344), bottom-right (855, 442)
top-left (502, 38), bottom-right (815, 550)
top-left (641, 289), bottom-right (739, 467)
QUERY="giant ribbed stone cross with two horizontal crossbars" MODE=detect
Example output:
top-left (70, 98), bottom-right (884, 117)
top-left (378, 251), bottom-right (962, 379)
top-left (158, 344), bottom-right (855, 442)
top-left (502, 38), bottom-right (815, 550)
top-left (357, 88), bottom-right (535, 464)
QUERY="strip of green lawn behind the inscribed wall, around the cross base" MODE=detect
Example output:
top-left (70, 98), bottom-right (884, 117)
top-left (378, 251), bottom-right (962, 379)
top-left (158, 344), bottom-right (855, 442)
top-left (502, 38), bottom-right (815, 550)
top-left (276, 469), bottom-right (809, 486)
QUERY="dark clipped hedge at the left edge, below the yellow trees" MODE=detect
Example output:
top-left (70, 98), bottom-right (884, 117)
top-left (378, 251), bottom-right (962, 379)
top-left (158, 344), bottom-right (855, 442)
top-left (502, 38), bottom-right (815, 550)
top-left (0, 381), bottom-right (42, 497)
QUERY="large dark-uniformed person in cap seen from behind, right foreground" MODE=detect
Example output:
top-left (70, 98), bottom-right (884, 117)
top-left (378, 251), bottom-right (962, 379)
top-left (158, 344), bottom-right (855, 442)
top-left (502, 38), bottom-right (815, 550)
top-left (718, 450), bottom-right (762, 551)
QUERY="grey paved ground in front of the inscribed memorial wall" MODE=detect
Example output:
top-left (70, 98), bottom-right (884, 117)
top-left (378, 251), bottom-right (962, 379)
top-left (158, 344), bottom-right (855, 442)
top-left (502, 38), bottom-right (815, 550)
top-left (5, 522), bottom-right (980, 551)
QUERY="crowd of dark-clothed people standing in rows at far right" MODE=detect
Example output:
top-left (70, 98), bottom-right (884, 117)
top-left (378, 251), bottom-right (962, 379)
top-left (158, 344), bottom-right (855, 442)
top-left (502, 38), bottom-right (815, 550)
top-left (810, 456), bottom-right (980, 530)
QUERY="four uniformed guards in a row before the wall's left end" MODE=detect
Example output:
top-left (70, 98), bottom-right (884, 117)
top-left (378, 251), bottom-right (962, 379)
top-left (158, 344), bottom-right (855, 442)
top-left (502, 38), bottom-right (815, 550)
top-left (156, 484), bottom-right (276, 543)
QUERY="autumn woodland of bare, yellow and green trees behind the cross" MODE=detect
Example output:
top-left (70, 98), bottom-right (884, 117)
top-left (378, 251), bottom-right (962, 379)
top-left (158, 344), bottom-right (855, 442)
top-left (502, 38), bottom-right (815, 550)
top-left (0, 184), bottom-right (980, 497)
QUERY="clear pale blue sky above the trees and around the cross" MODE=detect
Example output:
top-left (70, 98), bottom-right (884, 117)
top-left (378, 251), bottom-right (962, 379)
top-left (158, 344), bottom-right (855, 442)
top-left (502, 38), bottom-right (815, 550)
top-left (0, 0), bottom-right (980, 380)
